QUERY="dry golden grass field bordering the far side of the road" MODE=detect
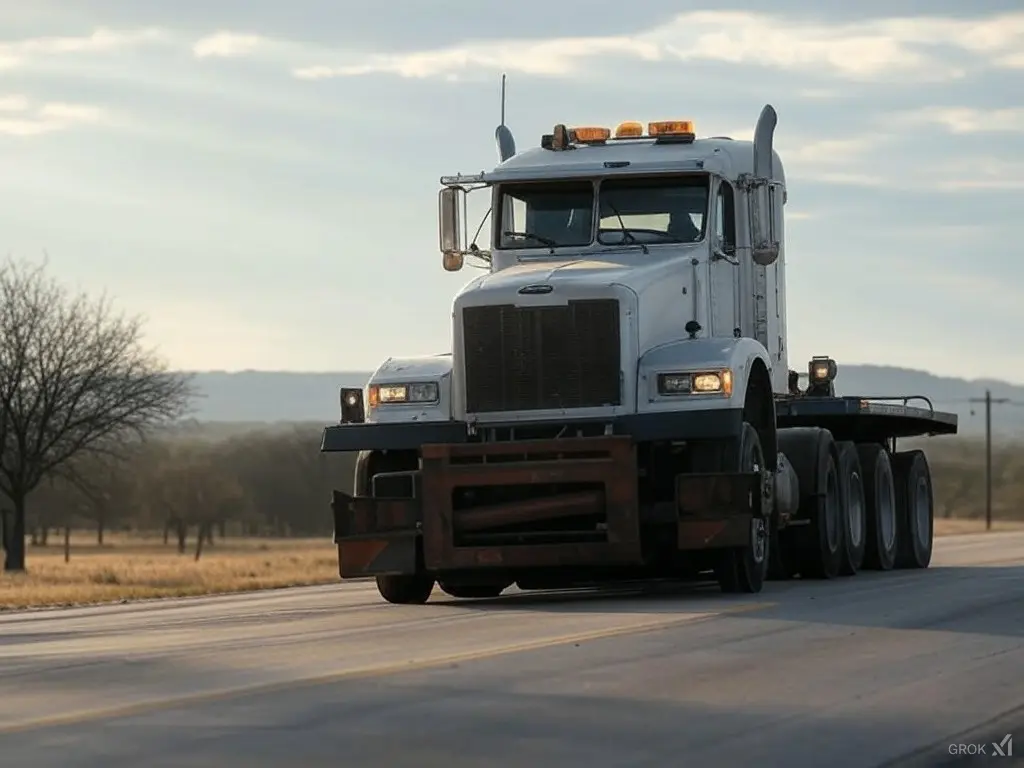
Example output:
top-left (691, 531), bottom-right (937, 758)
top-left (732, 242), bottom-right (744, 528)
top-left (0, 519), bottom-right (1024, 610)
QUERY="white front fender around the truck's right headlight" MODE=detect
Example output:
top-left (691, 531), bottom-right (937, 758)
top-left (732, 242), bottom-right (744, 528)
top-left (637, 338), bottom-right (771, 413)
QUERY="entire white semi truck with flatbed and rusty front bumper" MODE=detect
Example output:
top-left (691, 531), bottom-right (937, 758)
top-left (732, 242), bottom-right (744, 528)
top-left (322, 105), bottom-right (956, 603)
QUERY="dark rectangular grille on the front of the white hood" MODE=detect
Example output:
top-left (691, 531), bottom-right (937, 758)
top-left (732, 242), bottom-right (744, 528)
top-left (462, 299), bottom-right (622, 413)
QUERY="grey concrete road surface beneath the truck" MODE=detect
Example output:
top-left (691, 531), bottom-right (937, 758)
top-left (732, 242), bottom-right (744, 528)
top-left (0, 534), bottom-right (1024, 768)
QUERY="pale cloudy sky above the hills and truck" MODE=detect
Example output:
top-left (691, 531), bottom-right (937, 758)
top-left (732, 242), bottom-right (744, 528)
top-left (0, 0), bottom-right (1024, 383)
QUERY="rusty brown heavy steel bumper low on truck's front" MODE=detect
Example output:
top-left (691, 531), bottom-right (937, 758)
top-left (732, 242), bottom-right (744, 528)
top-left (332, 435), bottom-right (762, 578)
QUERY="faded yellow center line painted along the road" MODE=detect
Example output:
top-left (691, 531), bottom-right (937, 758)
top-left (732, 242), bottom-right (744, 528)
top-left (0, 602), bottom-right (777, 734)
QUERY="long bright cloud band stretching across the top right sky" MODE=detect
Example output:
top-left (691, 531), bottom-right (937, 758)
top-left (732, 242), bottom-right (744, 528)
top-left (280, 11), bottom-right (1024, 82)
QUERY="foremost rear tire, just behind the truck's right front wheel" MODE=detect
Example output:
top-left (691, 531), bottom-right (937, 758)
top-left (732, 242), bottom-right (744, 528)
top-left (778, 427), bottom-right (847, 579)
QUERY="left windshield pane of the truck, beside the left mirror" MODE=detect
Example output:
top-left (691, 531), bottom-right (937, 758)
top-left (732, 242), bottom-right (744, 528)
top-left (498, 181), bottom-right (594, 249)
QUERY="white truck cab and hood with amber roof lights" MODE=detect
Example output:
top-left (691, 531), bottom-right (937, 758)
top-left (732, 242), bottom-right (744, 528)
top-left (440, 108), bottom-right (788, 424)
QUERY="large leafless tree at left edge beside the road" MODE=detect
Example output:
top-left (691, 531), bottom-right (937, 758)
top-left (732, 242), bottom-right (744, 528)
top-left (0, 259), bottom-right (191, 570)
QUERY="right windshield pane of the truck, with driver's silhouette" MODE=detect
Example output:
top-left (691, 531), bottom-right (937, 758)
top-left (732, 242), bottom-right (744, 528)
top-left (597, 174), bottom-right (709, 246)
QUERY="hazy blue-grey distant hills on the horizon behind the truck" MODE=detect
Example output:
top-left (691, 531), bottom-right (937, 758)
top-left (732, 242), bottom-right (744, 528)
top-left (184, 366), bottom-right (1024, 437)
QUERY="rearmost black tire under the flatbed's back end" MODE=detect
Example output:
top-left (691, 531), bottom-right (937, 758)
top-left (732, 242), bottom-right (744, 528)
top-left (892, 451), bottom-right (935, 568)
